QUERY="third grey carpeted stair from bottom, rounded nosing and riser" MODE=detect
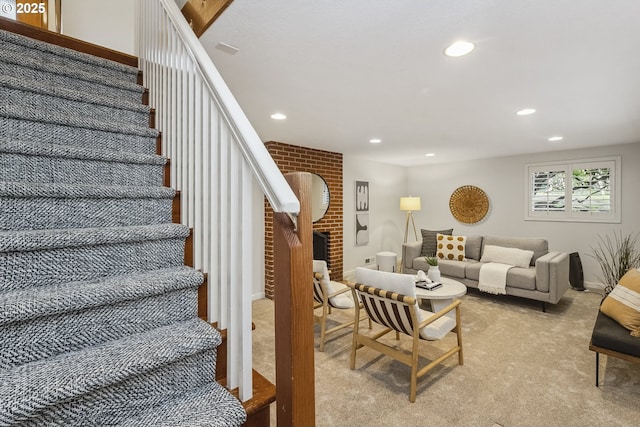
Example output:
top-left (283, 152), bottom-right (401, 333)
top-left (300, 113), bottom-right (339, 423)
top-left (0, 266), bottom-right (203, 370)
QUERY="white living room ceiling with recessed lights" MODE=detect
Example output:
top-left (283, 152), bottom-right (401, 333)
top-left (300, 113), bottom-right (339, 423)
top-left (201, 0), bottom-right (640, 166)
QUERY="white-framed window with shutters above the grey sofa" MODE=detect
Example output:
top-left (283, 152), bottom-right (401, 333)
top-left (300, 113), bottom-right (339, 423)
top-left (525, 157), bottom-right (620, 222)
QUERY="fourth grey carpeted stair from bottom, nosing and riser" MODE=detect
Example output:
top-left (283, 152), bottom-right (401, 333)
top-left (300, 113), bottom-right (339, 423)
top-left (0, 224), bottom-right (189, 291)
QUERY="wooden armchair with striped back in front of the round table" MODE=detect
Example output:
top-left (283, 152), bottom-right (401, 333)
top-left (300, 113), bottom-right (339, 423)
top-left (348, 268), bottom-right (463, 402)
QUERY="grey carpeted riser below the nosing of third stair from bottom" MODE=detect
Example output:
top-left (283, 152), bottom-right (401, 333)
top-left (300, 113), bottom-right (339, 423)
top-left (0, 288), bottom-right (198, 370)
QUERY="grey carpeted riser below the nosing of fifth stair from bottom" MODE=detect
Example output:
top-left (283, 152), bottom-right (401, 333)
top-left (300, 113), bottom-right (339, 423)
top-left (0, 197), bottom-right (172, 231)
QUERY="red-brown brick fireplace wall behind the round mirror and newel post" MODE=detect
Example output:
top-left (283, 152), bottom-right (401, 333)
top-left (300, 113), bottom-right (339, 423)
top-left (264, 141), bottom-right (343, 298)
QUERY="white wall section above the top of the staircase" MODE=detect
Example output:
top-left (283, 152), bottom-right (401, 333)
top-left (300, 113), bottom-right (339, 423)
top-left (61, 0), bottom-right (136, 55)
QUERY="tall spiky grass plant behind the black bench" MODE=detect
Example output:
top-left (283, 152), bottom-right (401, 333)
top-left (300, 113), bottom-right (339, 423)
top-left (591, 232), bottom-right (640, 296)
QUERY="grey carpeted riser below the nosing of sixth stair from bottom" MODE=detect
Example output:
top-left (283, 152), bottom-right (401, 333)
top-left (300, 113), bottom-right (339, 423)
top-left (0, 154), bottom-right (163, 186)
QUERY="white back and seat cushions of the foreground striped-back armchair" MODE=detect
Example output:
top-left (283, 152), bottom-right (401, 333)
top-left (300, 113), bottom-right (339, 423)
top-left (356, 267), bottom-right (456, 340)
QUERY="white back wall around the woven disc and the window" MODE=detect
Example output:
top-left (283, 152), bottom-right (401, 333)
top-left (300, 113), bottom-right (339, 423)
top-left (407, 143), bottom-right (640, 282)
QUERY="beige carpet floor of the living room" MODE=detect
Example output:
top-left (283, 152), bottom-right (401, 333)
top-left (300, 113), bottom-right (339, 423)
top-left (253, 290), bottom-right (640, 427)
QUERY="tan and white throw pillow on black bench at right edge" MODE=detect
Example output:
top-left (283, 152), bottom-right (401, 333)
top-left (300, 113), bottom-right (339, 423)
top-left (600, 268), bottom-right (640, 337)
